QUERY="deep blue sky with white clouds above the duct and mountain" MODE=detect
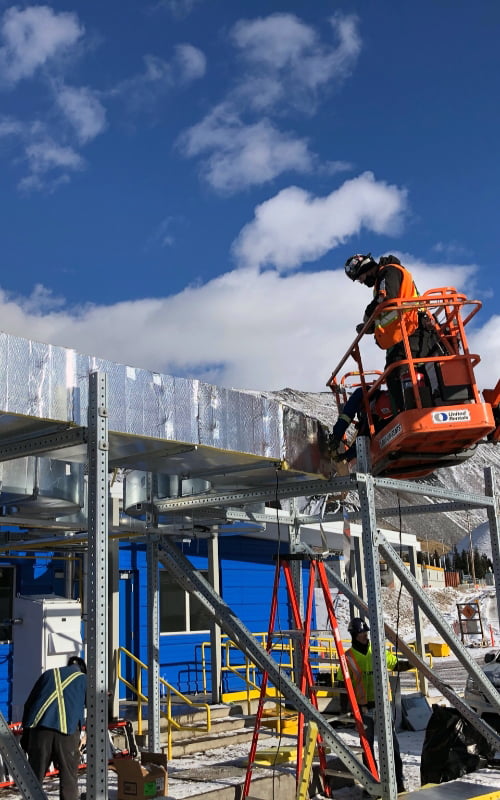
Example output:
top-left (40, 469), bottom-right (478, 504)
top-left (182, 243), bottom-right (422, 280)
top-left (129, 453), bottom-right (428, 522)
top-left (0, 0), bottom-right (500, 391)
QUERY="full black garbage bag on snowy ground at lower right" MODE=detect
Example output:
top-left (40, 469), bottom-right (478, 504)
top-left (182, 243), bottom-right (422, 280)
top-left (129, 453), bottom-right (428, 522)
top-left (420, 705), bottom-right (495, 785)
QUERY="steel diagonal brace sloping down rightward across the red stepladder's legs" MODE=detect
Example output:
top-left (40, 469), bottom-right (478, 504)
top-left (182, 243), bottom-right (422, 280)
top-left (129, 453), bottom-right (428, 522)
top-left (159, 537), bottom-right (380, 796)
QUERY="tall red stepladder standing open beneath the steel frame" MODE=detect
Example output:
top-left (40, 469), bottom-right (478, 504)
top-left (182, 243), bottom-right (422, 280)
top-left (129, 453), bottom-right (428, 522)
top-left (242, 553), bottom-right (379, 800)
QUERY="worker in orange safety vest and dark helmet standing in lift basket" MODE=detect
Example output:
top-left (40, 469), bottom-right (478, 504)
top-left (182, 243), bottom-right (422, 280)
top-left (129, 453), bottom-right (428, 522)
top-left (345, 253), bottom-right (441, 413)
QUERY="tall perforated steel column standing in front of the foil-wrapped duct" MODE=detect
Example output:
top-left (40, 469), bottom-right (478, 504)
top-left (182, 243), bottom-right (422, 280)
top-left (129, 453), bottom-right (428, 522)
top-left (87, 372), bottom-right (109, 800)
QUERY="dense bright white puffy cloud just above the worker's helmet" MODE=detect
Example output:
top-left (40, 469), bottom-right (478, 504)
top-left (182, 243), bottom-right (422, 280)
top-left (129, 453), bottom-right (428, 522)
top-left (233, 172), bottom-right (406, 271)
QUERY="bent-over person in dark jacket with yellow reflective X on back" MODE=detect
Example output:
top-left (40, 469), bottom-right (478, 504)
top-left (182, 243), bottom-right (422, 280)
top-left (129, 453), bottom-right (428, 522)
top-left (21, 656), bottom-right (87, 800)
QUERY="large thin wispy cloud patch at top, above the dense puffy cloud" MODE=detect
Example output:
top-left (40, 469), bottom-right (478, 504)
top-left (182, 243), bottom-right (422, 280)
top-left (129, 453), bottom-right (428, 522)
top-left (179, 14), bottom-right (361, 192)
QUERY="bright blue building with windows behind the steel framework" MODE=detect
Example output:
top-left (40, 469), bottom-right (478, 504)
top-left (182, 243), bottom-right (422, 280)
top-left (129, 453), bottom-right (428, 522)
top-left (0, 536), bottom-right (304, 721)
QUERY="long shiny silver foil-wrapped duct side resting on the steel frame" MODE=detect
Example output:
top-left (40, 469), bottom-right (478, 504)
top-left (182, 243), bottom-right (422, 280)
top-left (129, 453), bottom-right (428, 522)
top-left (0, 333), bottom-right (328, 472)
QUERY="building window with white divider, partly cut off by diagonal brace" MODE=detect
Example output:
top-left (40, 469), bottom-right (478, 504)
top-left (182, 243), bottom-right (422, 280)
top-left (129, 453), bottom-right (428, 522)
top-left (160, 570), bottom-right (210, 633)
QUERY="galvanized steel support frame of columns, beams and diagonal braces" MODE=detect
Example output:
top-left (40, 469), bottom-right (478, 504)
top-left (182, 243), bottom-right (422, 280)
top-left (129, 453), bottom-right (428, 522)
top-left (0, 372), bottom-right (500, 800)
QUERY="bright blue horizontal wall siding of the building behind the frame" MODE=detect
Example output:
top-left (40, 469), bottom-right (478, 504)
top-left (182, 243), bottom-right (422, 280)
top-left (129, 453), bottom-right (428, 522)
top-left (0, 537), bottom-right (312, 718)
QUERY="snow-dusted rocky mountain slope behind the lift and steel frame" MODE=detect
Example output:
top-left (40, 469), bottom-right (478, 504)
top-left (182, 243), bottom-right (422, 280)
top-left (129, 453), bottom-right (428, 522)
top-left (260, 388), bottom-right (500, 552)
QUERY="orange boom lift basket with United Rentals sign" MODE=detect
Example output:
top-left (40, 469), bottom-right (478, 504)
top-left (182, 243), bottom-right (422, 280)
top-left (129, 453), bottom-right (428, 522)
top-left (327, 287), bottom-right (500, 478)
